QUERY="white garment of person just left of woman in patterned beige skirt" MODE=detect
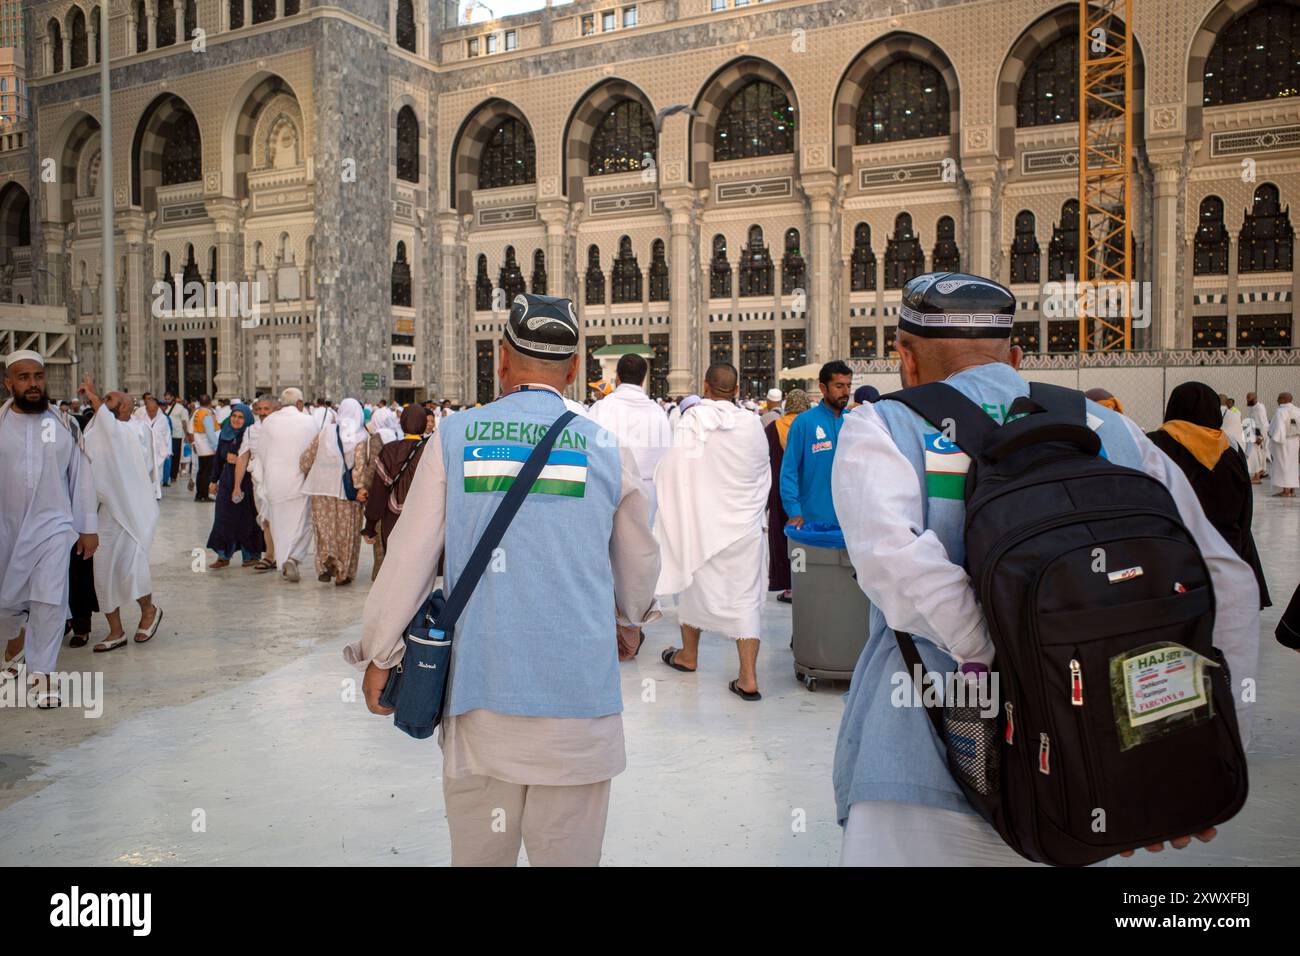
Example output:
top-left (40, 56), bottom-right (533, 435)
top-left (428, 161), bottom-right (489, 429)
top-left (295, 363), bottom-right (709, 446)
top-left (257, 405), bottom-right (316, 563)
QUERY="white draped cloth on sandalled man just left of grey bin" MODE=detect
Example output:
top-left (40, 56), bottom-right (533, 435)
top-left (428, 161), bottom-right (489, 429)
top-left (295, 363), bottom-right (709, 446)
top-left (654, 399), bottom-right (772, 639)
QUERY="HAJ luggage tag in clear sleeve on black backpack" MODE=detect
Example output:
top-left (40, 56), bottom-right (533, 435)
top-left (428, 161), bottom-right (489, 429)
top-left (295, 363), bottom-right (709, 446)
top-left (1110, 641), bottom-right (1219, 750)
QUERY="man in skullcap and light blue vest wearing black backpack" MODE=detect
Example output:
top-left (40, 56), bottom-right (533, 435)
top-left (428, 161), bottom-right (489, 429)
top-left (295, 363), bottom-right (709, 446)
top-left (831, 273), bottom-right (1260, 866)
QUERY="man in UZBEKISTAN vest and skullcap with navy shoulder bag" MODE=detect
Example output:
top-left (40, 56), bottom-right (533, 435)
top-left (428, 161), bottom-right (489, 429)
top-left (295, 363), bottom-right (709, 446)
top-left (345, 294), bottom-right (662, 866)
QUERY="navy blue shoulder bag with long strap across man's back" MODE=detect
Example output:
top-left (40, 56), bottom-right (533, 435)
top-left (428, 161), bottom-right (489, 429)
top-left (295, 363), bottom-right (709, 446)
top-left (380, 411), bottom-right (575, 740)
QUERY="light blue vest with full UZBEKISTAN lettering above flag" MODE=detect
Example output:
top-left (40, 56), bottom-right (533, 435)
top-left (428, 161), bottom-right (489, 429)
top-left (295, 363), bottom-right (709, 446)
top-left (438, 389), bottom-right (623, 717)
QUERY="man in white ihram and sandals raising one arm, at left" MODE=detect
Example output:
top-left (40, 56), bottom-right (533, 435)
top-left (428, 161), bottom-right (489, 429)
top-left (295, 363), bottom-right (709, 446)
top-left (79, 376), bottom-right (163, 652)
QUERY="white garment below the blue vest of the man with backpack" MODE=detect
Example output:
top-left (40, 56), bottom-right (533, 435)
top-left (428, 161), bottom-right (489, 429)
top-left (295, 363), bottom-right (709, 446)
top-left (840, 800), bottom-right (1037, 866)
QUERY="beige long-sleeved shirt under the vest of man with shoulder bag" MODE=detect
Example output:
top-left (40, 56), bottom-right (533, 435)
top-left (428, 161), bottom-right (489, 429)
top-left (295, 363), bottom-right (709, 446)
top-left (343, 432), bottom-right (663, 787)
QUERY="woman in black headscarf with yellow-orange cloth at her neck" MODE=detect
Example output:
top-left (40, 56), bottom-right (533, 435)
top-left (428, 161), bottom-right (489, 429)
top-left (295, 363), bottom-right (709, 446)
top-left (1147, 381), bottom-right (1271, 607)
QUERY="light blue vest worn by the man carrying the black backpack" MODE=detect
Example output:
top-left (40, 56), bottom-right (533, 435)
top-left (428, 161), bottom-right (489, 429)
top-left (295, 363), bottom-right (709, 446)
top-left (835, 363), bottom-right (1141, 826)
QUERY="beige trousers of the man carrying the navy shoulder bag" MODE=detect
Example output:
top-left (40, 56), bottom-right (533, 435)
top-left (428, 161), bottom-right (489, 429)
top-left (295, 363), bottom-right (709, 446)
top-left (442, 775), bottom-right (610, 866)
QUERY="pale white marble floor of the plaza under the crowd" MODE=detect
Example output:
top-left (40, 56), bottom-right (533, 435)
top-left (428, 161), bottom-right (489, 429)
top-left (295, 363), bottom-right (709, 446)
top-left (0, 488), bottom-right (1300, 866)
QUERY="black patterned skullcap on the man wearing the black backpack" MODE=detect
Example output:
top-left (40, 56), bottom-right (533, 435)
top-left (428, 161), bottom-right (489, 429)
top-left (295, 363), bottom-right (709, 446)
top-left (898, 272), bottom-right (1015, 338)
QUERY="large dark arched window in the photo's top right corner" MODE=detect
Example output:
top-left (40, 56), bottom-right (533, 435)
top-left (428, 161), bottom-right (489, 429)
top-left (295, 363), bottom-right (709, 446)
top-left (1203, 3), bottom-right (1300, 107)
